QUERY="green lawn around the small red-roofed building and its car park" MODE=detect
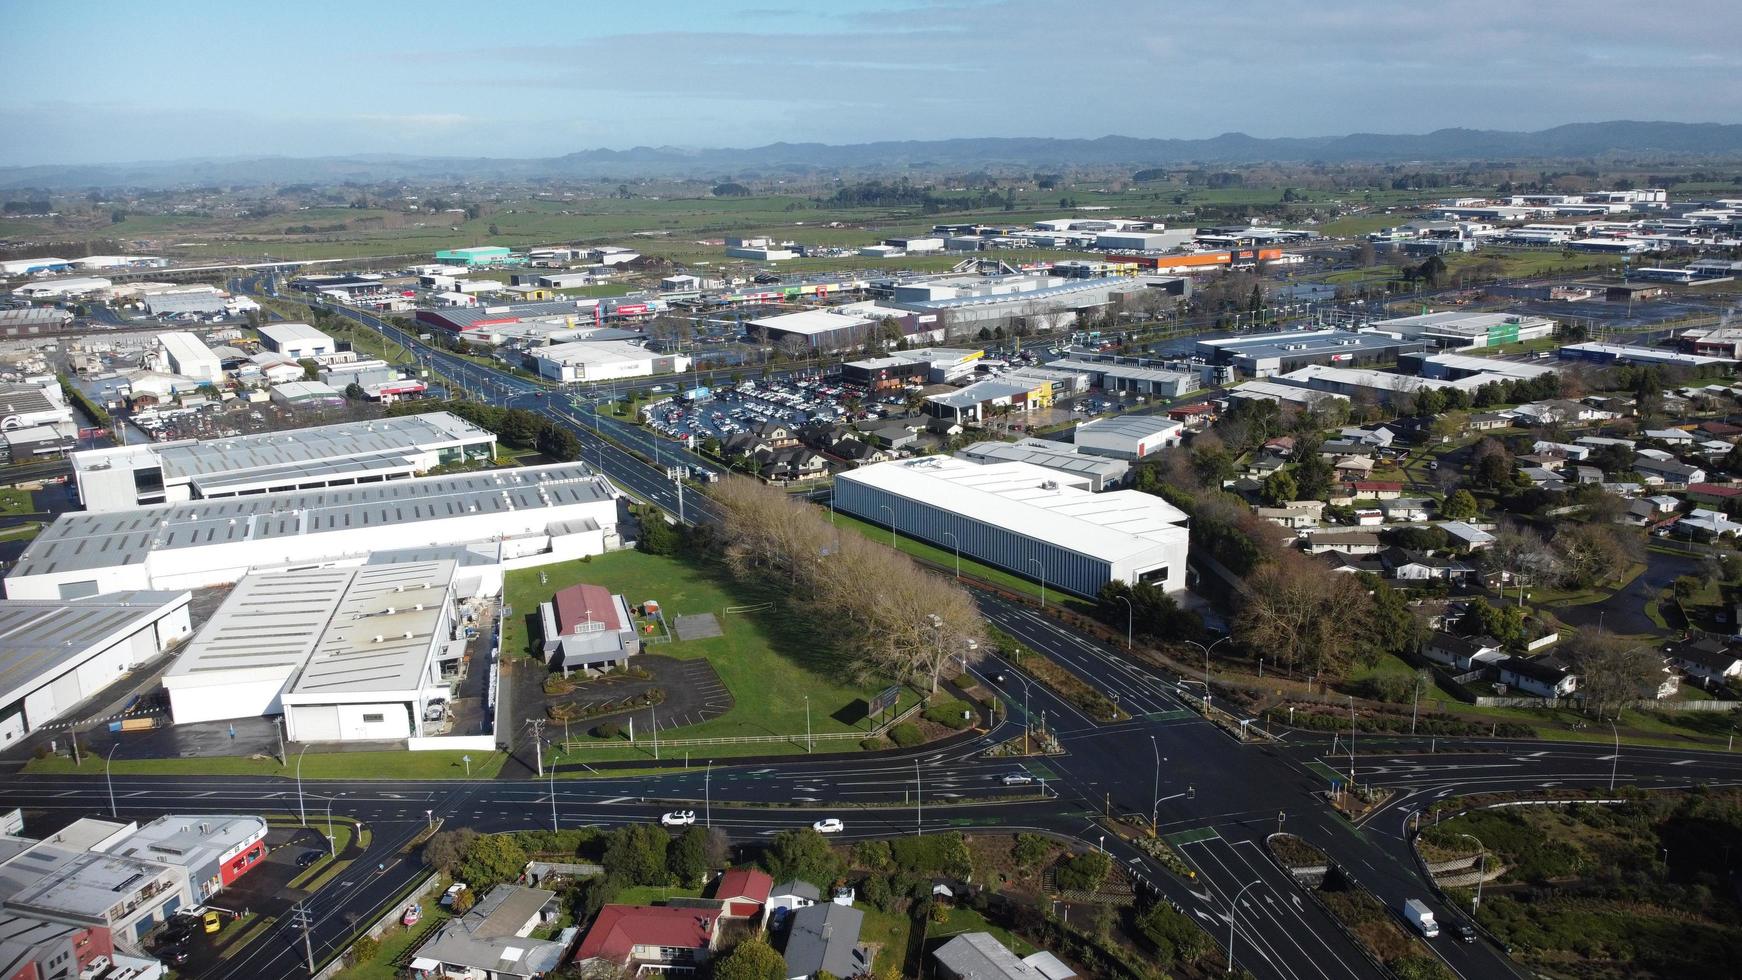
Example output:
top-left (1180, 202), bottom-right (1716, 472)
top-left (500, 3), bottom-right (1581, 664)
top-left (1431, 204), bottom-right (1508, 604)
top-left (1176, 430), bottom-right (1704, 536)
top-left (502, 552), bottom-right (918, 762)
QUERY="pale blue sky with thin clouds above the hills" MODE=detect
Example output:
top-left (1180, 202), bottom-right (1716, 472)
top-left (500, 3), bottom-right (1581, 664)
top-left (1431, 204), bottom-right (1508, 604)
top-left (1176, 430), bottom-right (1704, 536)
top-left (0, 0), bottom-right (1742, 165)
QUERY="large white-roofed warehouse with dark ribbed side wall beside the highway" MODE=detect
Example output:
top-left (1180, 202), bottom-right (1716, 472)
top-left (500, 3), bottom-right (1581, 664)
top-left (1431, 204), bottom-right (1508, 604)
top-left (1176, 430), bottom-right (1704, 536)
top-left (834, 456), bottom-right (1186, 597)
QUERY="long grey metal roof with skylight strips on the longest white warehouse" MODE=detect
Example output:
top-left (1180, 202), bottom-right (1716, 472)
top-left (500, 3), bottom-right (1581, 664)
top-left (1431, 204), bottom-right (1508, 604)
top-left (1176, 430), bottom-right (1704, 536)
top-left (12, 463), bottom-right (615, 578)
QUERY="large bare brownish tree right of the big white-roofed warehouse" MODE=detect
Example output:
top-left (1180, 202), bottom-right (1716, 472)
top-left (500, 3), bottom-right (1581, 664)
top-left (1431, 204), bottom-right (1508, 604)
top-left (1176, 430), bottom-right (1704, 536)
top-left (1235, 552), bottom-right (1373, 675)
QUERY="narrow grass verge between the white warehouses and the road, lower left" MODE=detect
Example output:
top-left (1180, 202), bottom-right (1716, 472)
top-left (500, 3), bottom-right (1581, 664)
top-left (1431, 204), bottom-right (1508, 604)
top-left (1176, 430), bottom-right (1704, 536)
top-left (24, 752), bottom-right (507, 783)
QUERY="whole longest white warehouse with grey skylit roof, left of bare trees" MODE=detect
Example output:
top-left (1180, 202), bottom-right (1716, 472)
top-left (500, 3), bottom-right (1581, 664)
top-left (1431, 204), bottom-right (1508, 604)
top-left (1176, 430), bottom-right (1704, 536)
top-left (5, 463), bottom-right (617, 599)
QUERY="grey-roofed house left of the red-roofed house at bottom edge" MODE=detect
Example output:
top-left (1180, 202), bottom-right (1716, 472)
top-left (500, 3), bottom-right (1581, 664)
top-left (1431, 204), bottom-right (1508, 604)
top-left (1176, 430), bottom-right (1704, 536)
top-left (411, 884), bottom-right (568, 980)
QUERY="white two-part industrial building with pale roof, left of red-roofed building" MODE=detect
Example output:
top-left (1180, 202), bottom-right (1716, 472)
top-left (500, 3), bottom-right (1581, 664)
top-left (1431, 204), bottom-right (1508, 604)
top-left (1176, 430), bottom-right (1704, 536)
top-left (164, 560), bottom-right (463, 742)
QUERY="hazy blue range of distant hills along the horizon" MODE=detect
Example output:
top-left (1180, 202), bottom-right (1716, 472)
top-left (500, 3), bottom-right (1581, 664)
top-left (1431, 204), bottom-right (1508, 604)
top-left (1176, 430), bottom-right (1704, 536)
top-left (0, 122), bottom-right (1742, 190)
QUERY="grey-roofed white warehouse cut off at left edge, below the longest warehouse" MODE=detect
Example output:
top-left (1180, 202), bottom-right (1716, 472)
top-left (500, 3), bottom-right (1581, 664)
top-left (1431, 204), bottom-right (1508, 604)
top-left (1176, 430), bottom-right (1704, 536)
top-left (0, 592), bottom-right (192, 748)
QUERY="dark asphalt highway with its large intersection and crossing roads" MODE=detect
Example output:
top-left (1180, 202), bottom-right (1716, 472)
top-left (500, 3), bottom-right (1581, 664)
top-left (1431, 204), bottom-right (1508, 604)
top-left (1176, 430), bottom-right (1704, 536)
top-left (0, 299), bottom-right (1714, 980)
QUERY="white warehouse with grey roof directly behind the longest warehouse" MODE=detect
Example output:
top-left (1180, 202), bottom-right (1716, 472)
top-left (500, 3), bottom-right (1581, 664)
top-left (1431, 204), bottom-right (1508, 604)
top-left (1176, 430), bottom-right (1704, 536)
top-left (73, 413), bottom-right (496, 512)
